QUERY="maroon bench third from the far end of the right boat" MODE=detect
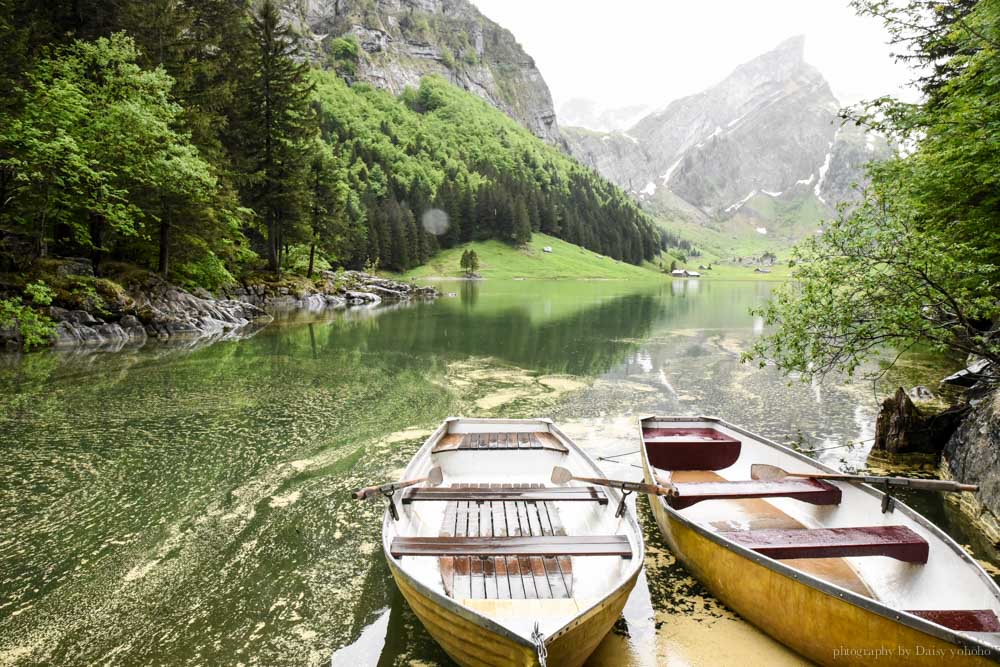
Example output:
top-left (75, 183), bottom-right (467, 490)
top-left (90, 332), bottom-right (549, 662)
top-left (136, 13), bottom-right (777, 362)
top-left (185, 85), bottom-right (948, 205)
top-left (719, 526), bottom-right (929, 563)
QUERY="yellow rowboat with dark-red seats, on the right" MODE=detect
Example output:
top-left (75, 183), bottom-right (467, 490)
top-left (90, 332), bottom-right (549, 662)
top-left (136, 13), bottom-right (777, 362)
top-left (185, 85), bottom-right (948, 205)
top-left (640, 417), bottom-right (1000, 665)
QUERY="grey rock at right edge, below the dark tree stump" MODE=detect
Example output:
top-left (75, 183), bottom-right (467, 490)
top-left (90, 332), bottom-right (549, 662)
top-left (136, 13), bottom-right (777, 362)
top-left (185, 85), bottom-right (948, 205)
top-left (941, 391), bottom-right (1000, 542)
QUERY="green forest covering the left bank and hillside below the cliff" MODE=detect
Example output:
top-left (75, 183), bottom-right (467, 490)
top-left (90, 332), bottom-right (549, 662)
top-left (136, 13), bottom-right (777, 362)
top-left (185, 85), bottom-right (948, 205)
top-left (0, 0), bottom-right (664, 289)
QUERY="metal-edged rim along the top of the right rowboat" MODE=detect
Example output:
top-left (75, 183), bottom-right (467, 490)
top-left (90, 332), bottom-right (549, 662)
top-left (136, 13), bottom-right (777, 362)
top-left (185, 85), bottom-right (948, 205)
top-left (639, 416), bottom-right (1000, 661)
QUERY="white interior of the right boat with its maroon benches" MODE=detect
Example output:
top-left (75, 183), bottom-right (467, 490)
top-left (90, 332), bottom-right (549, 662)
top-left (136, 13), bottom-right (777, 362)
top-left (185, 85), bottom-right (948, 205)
top-left (642, 418), bottom-right (1000, 645)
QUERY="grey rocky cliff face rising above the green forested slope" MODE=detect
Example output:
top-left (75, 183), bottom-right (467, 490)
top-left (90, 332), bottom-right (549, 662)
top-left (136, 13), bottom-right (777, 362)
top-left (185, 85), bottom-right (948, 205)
top-left (292, 0), bottom-right (562, 144)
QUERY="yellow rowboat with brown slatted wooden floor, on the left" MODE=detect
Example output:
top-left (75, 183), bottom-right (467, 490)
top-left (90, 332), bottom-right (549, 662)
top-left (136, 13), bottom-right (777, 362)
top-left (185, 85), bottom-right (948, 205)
top-left (382, 418), bottom-right (644, 667)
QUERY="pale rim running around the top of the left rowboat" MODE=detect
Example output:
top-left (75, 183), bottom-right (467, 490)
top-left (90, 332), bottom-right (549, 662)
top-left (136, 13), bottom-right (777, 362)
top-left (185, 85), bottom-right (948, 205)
top-left (382, 417), bottom-right (645, 649)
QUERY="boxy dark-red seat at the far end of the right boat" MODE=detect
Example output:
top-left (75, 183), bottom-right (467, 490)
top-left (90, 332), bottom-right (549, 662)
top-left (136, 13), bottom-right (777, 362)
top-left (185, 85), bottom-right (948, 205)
top-left (642, 428), bottom-right (740, 470)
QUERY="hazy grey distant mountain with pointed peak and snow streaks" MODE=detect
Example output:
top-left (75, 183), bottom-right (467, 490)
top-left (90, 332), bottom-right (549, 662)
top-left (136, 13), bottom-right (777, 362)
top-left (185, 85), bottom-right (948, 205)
top-left (564, 37), bottom-right (888, 235)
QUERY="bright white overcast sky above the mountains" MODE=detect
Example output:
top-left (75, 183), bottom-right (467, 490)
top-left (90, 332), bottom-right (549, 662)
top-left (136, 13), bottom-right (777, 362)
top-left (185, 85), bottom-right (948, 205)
top-left (472, 0), bottom-right (912, 109)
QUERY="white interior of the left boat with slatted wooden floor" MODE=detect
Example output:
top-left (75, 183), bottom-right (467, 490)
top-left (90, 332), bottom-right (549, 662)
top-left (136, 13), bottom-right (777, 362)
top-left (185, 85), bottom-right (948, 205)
top-left (386, 419), bottom-right (642, 638)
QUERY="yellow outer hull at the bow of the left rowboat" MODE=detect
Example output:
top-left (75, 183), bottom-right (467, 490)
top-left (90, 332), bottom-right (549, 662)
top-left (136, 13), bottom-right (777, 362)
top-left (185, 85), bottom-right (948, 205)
top-left (387, 559), bottom-right (639, 667)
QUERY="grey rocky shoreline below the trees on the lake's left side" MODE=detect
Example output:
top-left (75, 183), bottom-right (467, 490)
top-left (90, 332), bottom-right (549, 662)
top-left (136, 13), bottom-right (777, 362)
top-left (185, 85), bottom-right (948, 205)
top-left (0, 271), bottom-right (440, 350)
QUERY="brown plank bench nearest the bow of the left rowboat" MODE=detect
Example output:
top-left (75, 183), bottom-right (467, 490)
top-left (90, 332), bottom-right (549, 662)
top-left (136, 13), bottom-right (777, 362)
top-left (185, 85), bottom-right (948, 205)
top-left (389, 535), bottom-right (632, 558)
